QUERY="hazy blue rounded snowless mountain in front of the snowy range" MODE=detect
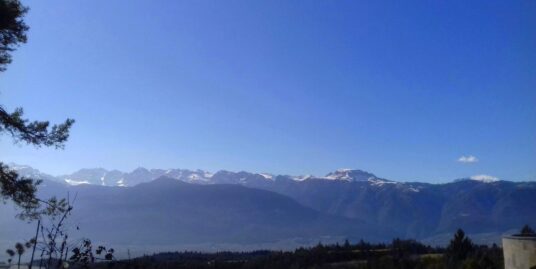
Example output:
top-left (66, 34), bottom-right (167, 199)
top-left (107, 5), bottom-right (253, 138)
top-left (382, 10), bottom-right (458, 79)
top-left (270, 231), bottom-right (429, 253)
top-left (0, 177), bottom-right (394, 255)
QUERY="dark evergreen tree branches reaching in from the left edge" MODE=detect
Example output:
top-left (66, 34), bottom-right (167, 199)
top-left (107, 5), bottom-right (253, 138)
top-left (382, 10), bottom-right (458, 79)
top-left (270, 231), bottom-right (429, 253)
top-left (0, 0), bottom-right (74, 212)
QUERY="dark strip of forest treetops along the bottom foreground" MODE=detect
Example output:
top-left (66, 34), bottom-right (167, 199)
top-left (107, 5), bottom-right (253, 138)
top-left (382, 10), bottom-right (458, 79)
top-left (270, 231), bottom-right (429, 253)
top-left (87, 231), bottom-right (503, 269)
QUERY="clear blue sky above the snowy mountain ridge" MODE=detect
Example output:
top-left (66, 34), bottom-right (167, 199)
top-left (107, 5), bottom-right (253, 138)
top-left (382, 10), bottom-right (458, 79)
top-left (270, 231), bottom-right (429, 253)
top-left (0, 0), bottom-right (536, 182)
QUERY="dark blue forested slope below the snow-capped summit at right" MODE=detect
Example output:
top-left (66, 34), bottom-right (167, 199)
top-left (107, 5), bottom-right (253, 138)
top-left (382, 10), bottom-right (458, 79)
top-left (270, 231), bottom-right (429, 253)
top-left (242, 178), bottom-right (536, 238)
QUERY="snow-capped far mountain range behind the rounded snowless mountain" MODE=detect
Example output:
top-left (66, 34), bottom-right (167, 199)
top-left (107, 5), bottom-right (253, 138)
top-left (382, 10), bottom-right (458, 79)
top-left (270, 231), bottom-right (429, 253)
top-left (6, 163), bottom-right (536, 243)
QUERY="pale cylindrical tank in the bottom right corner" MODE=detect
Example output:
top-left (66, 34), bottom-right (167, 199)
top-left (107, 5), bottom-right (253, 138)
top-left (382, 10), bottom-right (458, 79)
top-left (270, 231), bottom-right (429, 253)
top-left (503, 236), bottom-right (536, 269)
